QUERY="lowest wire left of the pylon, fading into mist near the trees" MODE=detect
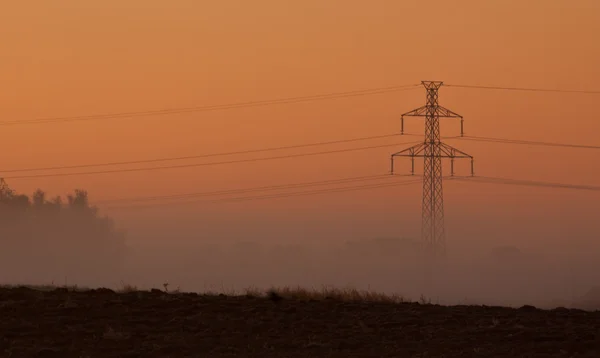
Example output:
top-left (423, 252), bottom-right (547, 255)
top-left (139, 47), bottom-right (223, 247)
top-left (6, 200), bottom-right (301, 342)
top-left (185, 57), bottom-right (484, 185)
top-left (105, 176), bottom-right (421, 210)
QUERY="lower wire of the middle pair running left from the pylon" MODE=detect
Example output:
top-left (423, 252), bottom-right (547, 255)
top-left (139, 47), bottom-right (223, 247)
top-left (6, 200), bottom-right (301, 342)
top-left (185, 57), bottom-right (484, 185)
top-left (4, 142), bottom-right (422, 179)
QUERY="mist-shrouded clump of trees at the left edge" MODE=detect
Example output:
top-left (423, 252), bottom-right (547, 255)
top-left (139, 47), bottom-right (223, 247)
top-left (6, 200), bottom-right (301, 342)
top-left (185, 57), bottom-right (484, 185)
top-left (0, 184), bottom-right (127, 282)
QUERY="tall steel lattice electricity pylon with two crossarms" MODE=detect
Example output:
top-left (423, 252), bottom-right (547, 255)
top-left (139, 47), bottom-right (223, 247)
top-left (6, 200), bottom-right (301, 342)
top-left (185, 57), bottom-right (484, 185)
top-left (391, 81), bottom-right (474, 258)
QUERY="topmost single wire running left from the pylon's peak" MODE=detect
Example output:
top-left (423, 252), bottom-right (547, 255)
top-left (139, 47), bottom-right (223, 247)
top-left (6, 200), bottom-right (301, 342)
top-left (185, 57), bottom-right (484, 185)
top-left (0, 84), bottom-right (418, 126)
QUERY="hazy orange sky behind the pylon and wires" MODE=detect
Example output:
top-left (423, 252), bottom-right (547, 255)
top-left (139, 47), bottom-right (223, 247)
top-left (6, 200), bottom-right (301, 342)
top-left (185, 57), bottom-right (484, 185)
top-left (0, 0), bottom-right (600, 249)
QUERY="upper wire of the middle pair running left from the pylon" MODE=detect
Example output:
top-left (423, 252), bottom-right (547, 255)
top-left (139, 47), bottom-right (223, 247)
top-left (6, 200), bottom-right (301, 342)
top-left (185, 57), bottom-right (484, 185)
top-left (0, 134), bottom-right (400, 173)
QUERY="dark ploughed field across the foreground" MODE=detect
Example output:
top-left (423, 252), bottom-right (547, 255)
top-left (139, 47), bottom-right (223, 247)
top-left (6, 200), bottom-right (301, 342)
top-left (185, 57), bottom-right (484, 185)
top-left (0, 288), bottom-right (600, 357)
